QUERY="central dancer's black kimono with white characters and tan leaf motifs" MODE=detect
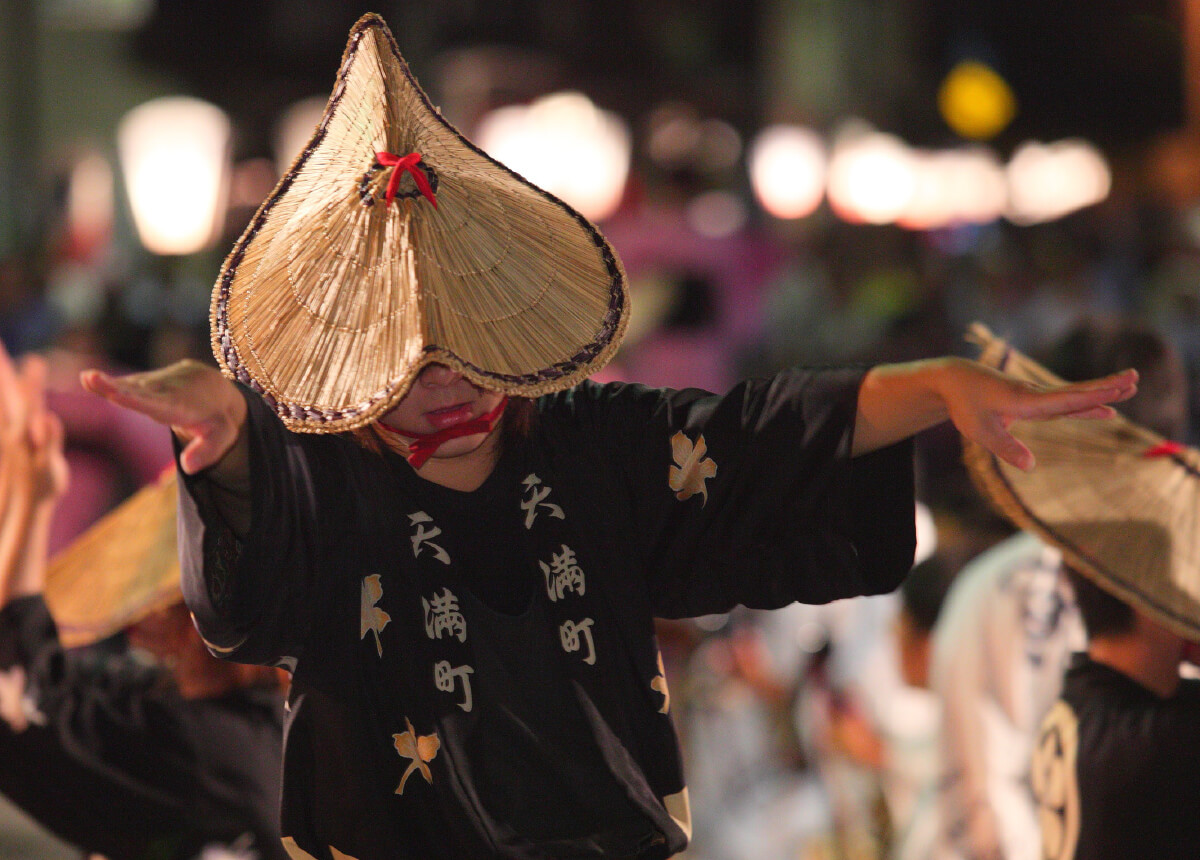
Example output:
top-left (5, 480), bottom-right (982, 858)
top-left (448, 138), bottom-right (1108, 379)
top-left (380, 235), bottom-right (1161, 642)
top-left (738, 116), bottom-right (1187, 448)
top-left (180, 371), bottom-right (914, 860)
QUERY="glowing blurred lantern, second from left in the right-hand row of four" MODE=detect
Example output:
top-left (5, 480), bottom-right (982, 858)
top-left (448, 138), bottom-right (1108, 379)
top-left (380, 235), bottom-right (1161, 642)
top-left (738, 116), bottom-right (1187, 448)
top-left (827, 128), bottom-right (917, 224)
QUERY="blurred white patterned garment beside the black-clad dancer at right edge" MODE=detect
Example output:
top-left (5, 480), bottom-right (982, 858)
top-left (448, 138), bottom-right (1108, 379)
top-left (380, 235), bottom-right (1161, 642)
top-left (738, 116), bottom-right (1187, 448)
top-left (930, 534), bottom-right (1085, 860)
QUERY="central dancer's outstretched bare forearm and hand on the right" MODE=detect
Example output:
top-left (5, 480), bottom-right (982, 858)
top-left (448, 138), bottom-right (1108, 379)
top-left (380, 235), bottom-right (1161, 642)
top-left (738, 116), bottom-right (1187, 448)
top-left (853, 357), bottom-right (1138, 470)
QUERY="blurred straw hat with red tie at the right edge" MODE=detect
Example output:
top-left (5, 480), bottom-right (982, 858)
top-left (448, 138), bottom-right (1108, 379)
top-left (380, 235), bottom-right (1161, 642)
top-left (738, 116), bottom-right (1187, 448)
top-left (966, 324), bottom-right (1200, 639)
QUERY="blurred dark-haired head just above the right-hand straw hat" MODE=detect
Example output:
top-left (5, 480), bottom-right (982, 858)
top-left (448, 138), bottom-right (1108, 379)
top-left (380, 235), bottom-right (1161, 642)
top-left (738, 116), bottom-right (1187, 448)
top-left (1045, 318), bottom-right (1188, 441)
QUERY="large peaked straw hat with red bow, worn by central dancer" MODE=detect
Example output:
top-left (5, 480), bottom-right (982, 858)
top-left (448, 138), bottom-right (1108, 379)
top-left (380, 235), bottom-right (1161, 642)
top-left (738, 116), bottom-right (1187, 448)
top-left (212, 14), bottom-right (629, 433)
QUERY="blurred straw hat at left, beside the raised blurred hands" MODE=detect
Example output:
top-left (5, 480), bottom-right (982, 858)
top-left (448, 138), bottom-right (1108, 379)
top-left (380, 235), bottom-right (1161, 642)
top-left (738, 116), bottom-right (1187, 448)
top-left (46, 469), bottom-right (184, 648)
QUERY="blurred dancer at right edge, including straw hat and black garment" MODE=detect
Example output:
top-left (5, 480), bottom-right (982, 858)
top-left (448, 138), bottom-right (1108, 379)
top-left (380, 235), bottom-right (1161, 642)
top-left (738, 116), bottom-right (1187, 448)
top-left (966, 329), bottom-right (1200, 860)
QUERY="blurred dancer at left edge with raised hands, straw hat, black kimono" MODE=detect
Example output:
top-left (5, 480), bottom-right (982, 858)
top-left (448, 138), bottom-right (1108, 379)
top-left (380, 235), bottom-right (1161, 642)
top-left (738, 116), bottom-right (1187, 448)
top-left (0, 343), bottom-right (286, 860)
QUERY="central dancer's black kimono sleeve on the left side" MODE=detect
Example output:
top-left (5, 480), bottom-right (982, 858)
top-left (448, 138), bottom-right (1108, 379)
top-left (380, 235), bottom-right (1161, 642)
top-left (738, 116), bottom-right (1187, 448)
top-left (176, 386), bottom-right (325, 669)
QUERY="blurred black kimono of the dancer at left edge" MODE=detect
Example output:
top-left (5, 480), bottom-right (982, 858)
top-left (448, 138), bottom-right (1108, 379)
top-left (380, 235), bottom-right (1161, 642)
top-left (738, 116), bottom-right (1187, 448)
top-left (0, 597), bottom-right (286, 860)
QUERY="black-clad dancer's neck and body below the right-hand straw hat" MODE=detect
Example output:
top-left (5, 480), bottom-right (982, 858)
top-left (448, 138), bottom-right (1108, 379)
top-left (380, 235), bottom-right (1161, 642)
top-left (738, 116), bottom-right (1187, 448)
top-left (1033, 563), bottom-right (1200, 860)
